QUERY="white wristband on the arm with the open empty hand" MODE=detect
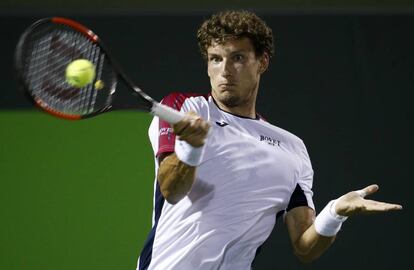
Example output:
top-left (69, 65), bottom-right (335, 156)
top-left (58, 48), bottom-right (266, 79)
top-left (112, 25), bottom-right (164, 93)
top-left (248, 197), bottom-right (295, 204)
top-left (314, 200), bottom-right (348, 237)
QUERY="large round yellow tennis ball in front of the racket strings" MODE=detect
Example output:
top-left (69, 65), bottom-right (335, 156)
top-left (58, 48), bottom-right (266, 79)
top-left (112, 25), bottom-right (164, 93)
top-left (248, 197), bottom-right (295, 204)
top-left (66, 59), bottom-right (95, 88)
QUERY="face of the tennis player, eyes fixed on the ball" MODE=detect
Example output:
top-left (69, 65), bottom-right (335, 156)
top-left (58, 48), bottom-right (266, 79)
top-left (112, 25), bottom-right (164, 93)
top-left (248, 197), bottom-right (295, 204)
top-left (207, 38), bottom-right (268, 109)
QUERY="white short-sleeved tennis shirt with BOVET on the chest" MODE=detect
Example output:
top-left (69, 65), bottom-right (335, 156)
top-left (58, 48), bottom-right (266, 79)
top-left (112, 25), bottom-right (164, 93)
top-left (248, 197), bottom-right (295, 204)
top-left (137, 93), bottom-right (314, 270)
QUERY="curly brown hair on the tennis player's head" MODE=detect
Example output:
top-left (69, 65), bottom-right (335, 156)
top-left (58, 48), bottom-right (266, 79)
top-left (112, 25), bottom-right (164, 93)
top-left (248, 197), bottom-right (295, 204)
top-left (197, 10), bottom-right (273, 59)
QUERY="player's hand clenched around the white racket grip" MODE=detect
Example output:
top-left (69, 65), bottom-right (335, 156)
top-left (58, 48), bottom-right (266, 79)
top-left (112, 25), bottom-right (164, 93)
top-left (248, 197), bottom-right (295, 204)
top-left (173, 112), bottom-right (210, 147)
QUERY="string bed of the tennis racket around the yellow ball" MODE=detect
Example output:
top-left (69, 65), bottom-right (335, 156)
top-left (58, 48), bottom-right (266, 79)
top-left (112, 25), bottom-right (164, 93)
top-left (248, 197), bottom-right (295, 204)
top-left (23, 24), bottom-right (116, 115)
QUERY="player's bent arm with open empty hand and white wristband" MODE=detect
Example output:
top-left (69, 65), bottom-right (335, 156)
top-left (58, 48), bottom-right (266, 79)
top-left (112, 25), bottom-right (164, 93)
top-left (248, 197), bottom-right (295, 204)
top-left (285, 185), bottom-right (402, 262)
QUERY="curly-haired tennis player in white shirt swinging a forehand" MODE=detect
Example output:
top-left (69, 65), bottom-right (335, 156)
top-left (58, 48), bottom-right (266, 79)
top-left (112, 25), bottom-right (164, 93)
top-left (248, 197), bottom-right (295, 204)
top-left (137, 11), bottom-right (402, 270)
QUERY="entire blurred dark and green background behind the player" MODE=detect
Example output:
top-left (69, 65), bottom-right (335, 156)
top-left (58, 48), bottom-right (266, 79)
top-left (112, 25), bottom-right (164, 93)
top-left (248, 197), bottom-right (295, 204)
top-left (0, 0), bottom-right (414, 270)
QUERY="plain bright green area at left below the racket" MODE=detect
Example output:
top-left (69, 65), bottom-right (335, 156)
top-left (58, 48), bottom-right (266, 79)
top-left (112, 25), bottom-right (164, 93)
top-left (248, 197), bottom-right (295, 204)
top-left (0, 110), bottom-right (154, 270)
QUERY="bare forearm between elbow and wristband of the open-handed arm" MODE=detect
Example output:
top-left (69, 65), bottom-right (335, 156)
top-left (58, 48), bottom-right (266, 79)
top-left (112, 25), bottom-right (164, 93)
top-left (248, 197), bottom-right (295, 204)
top-left (294, 225), bottom-right (335, 263)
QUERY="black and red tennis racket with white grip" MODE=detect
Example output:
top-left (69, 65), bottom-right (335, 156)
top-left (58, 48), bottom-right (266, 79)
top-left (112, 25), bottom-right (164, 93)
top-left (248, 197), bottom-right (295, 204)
top-left (15, 17), bottom-right (184, 124)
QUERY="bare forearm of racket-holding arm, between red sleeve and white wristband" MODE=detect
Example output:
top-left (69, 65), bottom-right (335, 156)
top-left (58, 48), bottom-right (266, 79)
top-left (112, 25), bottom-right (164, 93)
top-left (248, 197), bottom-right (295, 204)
top-left (158, 153), bottom-right (196, 204)
